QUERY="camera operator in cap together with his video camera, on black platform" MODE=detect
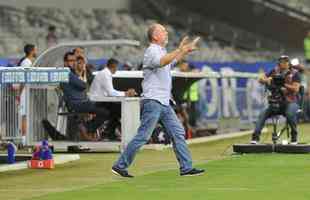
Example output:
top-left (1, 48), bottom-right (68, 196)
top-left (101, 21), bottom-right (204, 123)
top-left (251, 56), bottom-right (300, 144)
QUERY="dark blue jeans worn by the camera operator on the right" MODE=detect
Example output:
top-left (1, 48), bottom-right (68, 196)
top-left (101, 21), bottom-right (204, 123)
top-left (253, 102), bottom-right (299, 140)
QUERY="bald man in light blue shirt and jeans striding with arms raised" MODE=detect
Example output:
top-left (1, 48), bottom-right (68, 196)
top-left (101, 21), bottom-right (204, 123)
top-left (112, 24), bottom-right (204, 178)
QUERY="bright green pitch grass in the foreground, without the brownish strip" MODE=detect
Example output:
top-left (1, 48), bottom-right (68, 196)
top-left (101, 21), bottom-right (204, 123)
top-left (30, 154), bottom-right (310, 200)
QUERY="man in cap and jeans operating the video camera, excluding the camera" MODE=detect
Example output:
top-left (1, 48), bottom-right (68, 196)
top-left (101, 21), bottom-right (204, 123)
top-left (251, 56), bottom-right (300, 144)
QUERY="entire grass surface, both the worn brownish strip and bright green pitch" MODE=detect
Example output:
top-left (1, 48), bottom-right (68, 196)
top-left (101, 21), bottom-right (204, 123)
top-left (0, 125), bottom-right (310, 200)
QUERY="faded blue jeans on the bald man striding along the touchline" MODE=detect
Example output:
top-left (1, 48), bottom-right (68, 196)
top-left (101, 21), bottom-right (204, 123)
top-left (114, 99), bottom-right (192, 172)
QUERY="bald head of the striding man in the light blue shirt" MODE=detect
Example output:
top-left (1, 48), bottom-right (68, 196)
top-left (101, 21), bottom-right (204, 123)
top-left (147, 24), bottom-right (168, 46)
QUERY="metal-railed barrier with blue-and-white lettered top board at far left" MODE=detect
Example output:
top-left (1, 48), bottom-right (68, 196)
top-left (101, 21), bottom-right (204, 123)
top-left (0, 67), bottom-right (69, 145)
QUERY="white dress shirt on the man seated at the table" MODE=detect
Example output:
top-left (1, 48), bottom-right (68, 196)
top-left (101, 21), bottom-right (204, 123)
top-left (89, 67), bottom-right (125, 101)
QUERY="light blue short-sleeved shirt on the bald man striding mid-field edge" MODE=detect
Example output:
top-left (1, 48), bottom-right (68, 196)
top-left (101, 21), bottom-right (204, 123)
top-left (142, 43), bottom-right (176, 105)
